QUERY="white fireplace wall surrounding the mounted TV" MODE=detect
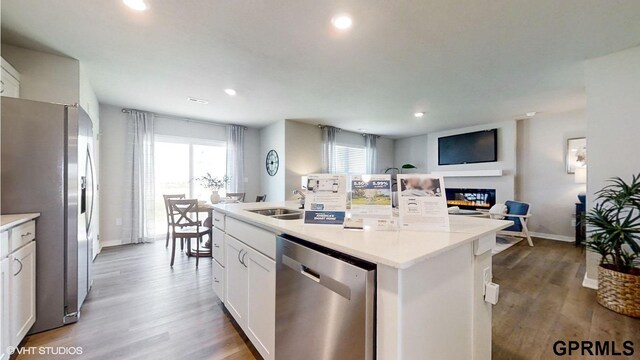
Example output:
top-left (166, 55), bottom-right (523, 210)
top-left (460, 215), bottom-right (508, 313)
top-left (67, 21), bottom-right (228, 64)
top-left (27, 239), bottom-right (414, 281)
top-left (428, 120), bottom-right (517, 203)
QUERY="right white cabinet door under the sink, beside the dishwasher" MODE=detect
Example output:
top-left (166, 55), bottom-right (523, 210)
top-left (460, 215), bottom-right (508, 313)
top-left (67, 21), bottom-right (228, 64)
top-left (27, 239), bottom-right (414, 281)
top-left (244, 247), bottom-right (276, 360)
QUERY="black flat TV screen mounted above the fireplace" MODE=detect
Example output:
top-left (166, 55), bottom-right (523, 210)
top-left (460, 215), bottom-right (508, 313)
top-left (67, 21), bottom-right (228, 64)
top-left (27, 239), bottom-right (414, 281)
top-left (438, 129), bottom-right (498, 165)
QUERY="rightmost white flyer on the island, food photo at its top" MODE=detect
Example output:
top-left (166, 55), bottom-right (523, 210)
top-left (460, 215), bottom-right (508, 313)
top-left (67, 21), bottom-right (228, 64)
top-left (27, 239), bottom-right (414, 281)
top-left (398, 174), bottom-right (449, 231)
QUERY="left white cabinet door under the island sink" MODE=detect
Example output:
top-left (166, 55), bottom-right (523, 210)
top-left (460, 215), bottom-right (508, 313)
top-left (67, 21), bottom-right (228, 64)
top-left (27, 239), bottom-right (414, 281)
top-left (224, 235), bottom-right (248, 329)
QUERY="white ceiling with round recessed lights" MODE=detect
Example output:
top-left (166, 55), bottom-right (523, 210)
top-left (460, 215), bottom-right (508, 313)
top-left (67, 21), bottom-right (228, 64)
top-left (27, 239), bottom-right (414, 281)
top-left (2, 0), bottom-right (640, 137)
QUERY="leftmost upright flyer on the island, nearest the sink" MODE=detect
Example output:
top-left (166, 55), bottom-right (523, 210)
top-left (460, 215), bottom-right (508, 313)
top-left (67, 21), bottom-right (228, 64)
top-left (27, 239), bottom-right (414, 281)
top-left (304, 174), bottom-right (347, 225)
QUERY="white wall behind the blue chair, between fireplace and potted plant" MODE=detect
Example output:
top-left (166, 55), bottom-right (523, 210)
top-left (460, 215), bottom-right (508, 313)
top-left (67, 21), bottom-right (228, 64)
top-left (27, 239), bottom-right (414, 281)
top-left (516, 110), bottom-right (586, 241)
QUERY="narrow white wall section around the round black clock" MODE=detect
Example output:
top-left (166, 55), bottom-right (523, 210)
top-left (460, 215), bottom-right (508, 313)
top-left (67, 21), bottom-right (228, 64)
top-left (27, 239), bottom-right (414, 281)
top-left (260, 120), bottom-right (286, 201)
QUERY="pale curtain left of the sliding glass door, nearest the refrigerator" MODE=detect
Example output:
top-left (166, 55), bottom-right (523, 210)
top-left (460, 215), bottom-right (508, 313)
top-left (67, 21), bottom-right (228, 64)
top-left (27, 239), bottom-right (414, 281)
top-left (122, 110), bottom-right (155, 244)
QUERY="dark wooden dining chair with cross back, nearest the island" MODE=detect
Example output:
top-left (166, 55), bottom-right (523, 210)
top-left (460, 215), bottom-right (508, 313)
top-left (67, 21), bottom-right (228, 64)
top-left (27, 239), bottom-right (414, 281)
top-left (168, 199), bottom-right (210, 268)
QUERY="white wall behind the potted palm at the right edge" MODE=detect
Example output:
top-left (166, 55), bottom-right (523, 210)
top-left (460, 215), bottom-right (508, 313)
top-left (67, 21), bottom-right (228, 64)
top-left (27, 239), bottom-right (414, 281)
top-left (585, 47), bottom-right (640, 286)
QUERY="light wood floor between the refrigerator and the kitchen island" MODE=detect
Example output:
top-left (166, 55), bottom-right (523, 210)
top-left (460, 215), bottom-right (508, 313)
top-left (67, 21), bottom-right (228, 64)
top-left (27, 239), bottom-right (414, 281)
top-left (18, 240), bottom-right (259, 360)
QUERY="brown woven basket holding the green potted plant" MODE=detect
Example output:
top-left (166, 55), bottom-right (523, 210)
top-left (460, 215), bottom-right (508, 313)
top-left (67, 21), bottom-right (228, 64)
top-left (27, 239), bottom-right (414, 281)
top-left (597, 265), bottom-right (640, 318)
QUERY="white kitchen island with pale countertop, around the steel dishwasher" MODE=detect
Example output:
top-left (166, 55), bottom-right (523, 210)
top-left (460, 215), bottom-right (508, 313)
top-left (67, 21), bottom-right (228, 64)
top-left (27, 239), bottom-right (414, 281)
top-left (213, 202), bottom-right (511, 360)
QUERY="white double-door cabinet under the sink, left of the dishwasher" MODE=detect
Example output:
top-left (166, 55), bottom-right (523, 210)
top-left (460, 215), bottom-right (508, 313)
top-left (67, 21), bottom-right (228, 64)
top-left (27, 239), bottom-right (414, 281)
top-left (225, 229), bottom-right (276, 360)
